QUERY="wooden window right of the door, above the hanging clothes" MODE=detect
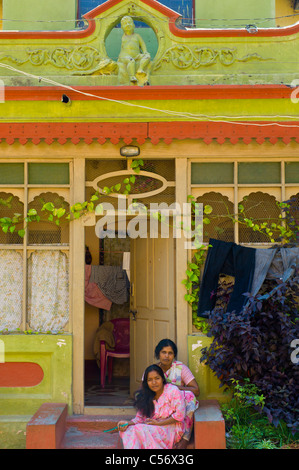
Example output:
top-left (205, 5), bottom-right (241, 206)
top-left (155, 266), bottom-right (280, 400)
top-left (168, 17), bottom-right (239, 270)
top-left (191, 161), bottom-right (299, 243)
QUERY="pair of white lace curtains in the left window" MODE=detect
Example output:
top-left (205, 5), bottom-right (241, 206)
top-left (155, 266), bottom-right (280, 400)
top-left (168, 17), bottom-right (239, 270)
top-left (0, 250), bottom-right (69, 332)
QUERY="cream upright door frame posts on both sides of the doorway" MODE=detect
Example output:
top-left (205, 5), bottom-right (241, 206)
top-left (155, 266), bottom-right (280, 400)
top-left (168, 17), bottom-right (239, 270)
top-left (70, 157), bottom-right (192, 414)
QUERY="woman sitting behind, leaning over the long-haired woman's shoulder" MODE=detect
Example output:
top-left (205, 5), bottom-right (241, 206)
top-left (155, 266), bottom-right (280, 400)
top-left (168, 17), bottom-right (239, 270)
top-left (155, 339), bottom-right (199, 449)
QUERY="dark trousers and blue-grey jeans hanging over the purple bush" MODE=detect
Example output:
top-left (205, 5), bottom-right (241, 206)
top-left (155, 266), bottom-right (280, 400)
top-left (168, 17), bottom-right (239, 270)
top-left (197, 238), bottom-right (299, 318)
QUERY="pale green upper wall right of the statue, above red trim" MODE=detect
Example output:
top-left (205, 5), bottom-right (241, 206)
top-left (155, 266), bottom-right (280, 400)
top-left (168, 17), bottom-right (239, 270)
top-left (195, 0), bottom-right (275, 28)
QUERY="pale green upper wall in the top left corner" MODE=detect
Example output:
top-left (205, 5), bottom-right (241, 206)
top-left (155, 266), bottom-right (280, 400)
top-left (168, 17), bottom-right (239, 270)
top-left (3, 0), bottom-right (77, 31)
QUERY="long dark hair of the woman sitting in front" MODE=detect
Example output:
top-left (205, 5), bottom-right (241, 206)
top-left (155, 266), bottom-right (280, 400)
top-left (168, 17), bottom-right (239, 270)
top-left (135, 364), bottom-right (166, 418)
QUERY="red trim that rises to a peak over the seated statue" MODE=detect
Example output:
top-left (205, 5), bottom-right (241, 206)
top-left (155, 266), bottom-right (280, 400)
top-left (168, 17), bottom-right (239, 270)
top-left (0, 0), bottom-right (299, 40)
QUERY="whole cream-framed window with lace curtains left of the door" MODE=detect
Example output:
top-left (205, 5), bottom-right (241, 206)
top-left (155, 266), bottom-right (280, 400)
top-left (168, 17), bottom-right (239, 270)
top-left (0, 162), bottom-right (70, 332)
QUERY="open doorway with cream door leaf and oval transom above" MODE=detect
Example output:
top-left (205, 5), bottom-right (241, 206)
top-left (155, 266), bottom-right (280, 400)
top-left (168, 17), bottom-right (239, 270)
top-left (84, 158), bottom-right (176, 407)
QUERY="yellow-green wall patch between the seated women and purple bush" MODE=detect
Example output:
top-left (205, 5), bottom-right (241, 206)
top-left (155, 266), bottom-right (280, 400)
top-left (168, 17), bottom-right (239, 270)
top-left (187, 334), bottom-right (230, 403)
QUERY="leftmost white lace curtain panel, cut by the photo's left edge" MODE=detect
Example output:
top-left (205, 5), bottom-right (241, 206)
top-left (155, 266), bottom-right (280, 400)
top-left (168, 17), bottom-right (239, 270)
top-left (0, 250), bottom-right (23, 331)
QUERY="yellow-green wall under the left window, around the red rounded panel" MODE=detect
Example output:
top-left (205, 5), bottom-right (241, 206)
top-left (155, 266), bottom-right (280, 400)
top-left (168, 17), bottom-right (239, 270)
top-left (0, 334), bottom-right (72, 414)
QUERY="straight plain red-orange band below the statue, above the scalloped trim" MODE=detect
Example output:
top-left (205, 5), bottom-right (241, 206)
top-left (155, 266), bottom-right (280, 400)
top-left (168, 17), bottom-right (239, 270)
top-left (5, 85), bottom-right (294, 101)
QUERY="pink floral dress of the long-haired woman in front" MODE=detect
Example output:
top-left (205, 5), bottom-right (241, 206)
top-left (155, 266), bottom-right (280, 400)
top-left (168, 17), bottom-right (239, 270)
top-left (119, 384), bottom-right (185, 449)
